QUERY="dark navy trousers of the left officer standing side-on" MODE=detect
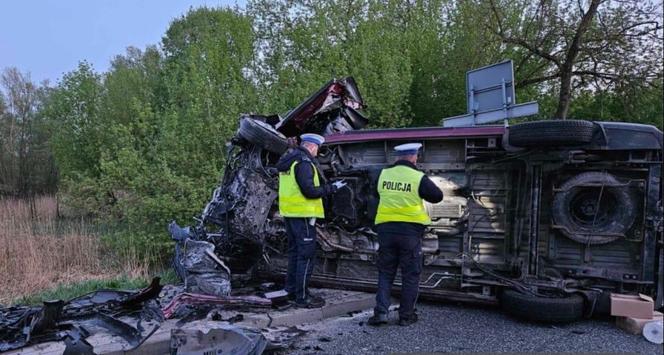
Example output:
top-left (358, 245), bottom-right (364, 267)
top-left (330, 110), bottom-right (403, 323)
top-left (284, 217), bottom-right (316, 301)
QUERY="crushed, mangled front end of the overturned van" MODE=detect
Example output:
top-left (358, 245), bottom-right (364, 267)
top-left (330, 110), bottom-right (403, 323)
top-left (168, 77), bottom-right (368, 297)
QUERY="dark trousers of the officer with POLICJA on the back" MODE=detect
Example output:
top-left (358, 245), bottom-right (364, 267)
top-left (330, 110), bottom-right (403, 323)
top-left (374, 231), bottom-right (422, 318)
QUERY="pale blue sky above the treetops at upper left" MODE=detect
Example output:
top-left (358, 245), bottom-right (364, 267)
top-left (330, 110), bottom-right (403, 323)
top-left (0, 0), bottom-right (245, 84)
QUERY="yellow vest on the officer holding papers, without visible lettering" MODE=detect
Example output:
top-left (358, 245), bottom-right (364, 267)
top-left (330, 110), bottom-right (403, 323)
top-left (279, 161), bottom-right (325, 218)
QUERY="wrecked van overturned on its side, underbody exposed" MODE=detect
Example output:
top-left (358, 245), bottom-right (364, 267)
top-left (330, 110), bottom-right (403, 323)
top-left (171, 66), bottom-right (664, 322)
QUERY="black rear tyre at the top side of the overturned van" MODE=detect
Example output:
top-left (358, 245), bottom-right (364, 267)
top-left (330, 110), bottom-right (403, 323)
top-left (508, 120), bottom-right (595, 147)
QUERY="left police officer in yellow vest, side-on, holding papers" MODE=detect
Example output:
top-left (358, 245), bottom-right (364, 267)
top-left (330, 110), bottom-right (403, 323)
top-left (277, 134), bottom-right (346, 308)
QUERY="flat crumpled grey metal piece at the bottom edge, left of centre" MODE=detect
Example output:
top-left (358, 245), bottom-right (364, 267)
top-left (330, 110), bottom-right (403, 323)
top-left (171, 324), bottom-right (268, 355)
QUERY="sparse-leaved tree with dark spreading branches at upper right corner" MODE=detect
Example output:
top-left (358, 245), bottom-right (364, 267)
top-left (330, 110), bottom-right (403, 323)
top-left (486, 0), bottom-right (662, 119)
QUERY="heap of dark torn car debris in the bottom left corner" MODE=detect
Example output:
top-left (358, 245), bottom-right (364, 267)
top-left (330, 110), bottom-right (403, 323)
top-left (0, 278), bottom-right (163, 353)
